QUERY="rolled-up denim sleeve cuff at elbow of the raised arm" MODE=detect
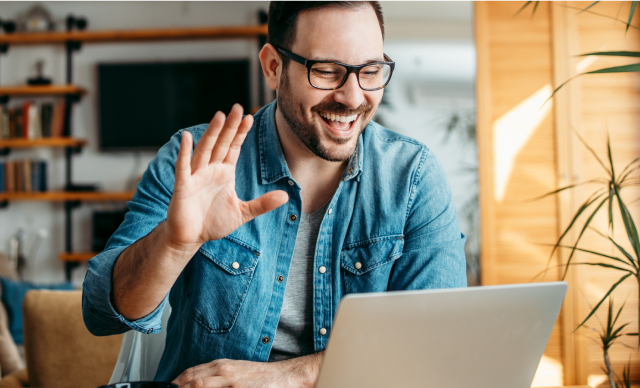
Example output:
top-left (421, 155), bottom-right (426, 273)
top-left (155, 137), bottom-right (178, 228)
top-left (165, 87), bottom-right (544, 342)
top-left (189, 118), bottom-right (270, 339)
top-left (82, 247), bottom-right (168, 336)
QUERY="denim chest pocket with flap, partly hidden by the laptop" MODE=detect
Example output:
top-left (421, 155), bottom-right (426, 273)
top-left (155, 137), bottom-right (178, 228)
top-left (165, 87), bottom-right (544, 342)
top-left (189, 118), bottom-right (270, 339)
top-left (340, 235), bottom-right (404, 294)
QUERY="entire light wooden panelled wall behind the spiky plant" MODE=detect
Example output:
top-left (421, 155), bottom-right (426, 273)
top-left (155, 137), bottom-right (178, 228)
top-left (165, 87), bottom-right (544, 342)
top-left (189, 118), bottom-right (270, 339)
top-left (475, 0), bottom-right (640, 385)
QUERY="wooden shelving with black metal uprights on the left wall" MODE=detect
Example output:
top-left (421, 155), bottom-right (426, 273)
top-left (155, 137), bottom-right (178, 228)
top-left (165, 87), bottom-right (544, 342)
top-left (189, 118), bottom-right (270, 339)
top-left (0, 20), bottom-right (268, 279)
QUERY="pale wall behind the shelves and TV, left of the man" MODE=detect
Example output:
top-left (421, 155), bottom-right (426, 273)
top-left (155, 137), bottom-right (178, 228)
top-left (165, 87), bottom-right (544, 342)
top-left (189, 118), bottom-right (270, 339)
top-left (0, 0), bottom-right (269, 282)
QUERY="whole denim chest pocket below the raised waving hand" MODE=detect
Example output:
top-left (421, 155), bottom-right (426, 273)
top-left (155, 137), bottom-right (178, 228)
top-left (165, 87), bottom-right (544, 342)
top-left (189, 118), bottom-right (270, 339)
top-left (189, 238), bottom-right (260, 333)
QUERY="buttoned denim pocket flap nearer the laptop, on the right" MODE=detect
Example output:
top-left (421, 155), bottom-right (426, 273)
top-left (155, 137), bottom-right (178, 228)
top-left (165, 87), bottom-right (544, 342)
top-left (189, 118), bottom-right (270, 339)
top-left (340, 235), bottom-right (404, 275)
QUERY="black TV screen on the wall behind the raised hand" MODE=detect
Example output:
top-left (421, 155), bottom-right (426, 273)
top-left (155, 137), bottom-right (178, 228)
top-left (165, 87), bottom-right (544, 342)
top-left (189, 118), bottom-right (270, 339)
top-left (98, 60), bottom-right (250, 151)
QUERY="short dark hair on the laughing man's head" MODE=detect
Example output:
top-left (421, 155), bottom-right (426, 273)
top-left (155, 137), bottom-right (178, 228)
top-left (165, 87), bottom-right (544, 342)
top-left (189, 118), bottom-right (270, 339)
top-left (269, 0), bottom-right (384, 52)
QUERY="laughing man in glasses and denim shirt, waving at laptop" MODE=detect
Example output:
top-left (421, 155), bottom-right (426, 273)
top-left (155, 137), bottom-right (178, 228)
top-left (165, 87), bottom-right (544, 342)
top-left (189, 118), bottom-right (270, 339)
top-left (83, 0), bottom-right (466, 387)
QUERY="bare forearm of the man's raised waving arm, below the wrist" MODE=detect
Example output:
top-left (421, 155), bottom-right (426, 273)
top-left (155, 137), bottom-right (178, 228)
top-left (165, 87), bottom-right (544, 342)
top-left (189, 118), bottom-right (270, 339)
top-left (111, 222), bottom-right (197, 320)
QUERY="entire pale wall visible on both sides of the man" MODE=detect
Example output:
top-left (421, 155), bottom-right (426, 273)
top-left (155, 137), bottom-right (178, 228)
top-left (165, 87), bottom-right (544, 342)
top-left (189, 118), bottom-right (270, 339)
top-left (0, 0), bottom-right (475, 283)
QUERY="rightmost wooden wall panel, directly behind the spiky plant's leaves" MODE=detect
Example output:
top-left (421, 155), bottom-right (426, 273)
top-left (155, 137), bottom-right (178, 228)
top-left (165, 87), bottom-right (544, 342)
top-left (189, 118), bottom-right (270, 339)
top-left (571, 0), bottom-right (640, 382)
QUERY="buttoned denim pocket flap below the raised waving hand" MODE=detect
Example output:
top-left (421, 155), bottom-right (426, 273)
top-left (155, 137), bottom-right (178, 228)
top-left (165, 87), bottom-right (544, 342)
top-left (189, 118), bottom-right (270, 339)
top-left (199, 236), bottom-right (260, 275)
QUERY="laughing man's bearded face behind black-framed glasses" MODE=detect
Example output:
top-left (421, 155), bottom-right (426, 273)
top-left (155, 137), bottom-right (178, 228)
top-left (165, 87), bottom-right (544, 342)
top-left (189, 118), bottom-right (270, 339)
top-left (278, 7), bottom-right (384, 162)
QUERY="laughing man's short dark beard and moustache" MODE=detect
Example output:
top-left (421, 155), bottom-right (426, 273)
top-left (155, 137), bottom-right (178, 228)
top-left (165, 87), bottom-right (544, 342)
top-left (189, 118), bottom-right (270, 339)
top-left (277, 72), bottom-right (376, 162)
